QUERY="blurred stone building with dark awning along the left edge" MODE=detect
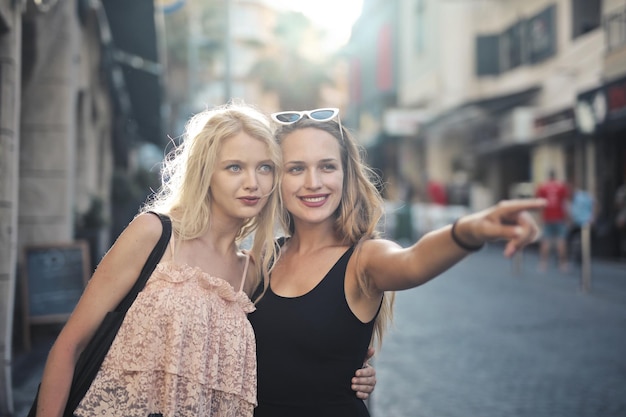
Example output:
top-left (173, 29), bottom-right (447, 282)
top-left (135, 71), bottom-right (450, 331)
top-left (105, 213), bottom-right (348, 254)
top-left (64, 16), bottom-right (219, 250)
top-left (0, 0), bottom-right (164, 416)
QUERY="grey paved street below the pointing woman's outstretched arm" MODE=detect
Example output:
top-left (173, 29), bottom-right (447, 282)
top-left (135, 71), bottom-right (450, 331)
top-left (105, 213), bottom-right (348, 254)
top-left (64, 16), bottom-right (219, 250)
top-left (370, 248), bottom-right (626, 417)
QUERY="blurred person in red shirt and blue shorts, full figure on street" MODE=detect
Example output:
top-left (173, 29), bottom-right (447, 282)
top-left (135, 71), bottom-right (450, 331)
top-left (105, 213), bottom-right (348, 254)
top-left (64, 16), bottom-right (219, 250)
top-left (536, 170), bottom-right (570, 272)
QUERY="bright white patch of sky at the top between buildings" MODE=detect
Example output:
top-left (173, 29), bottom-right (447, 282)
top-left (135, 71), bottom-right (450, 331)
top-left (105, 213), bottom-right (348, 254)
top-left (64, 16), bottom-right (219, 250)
top-left (272, 0), bottom-right (363, 47)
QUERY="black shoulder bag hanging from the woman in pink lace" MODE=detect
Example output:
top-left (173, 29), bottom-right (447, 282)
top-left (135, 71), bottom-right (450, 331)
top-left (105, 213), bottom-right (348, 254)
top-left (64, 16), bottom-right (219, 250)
top-left (28, 211), bottom-right (172, 417)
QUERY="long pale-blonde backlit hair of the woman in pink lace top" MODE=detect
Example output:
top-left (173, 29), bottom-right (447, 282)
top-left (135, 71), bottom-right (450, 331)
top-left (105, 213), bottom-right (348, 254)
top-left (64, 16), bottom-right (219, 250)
top-left (140, 102), bottom-right (282, 288)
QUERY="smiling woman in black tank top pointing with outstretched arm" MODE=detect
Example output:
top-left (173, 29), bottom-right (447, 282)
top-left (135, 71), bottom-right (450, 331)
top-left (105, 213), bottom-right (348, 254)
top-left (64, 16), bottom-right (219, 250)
top-left (249, 109), bottom-right (544, 417)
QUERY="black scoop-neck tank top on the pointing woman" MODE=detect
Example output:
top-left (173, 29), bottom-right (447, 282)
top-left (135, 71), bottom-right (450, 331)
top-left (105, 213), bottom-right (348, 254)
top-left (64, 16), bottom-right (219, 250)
top-left (248, 247), bottom-right (375, 417)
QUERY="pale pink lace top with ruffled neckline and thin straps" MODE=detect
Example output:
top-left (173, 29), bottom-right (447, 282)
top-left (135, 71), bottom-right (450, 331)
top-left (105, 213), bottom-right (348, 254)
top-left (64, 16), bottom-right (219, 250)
top-left (75, 252), bottom-right (256, 417)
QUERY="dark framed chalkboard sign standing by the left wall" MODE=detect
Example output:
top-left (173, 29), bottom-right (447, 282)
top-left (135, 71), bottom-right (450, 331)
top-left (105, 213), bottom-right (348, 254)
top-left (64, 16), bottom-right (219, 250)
top-left (21, 240), bottom-right (90, 348)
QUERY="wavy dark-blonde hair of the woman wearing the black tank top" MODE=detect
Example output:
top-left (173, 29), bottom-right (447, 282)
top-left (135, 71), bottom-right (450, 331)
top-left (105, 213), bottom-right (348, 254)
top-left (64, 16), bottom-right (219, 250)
top-left (276, 118), bottom-right (395, 346)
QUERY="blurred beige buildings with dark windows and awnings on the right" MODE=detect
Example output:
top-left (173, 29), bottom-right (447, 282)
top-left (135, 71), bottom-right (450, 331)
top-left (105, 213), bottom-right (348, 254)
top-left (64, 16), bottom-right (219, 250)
top-left (348, 0), bottom-right (626, 257)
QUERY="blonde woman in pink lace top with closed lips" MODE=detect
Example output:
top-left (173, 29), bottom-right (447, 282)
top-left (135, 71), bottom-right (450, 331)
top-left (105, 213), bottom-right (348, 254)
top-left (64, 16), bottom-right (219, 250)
top-left (37, 104), bottom-right (280, 417)
